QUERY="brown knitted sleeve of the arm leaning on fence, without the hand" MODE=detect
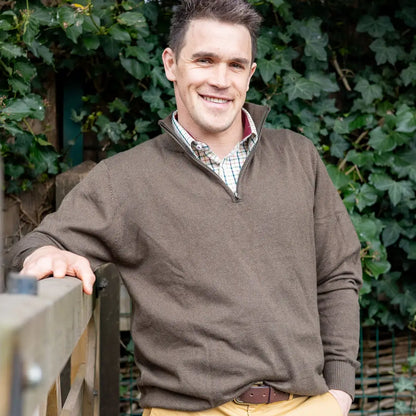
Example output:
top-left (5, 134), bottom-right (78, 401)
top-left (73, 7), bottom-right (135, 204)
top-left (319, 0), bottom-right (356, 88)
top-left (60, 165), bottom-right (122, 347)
top-left (7, 163), bottom-right (120, 270)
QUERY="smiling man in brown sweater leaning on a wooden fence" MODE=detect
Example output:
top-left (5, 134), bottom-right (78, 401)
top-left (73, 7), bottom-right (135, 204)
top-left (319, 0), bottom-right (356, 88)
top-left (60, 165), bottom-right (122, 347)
top-left (8, 0), bottom-right (361, 416)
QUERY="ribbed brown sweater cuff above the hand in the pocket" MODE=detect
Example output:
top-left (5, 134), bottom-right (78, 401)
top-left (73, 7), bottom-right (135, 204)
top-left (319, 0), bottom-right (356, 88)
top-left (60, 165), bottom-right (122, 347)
top-left (324, 361), bottom-right (355, 400)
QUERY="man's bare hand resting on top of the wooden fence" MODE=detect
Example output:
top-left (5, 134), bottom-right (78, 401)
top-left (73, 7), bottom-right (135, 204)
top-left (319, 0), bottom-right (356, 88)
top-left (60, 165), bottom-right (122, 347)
top-left (20, 246), bottom-right (95, 295)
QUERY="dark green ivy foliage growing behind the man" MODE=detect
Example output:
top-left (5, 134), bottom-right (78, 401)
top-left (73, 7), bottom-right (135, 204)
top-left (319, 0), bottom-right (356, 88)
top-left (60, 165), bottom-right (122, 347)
top-left (0, 0), bottom-right (416, 327)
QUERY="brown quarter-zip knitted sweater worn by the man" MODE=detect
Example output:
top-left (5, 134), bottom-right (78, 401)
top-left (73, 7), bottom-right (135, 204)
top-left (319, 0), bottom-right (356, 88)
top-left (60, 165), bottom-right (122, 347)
top-left (8, 104), bottom-right (361, 411)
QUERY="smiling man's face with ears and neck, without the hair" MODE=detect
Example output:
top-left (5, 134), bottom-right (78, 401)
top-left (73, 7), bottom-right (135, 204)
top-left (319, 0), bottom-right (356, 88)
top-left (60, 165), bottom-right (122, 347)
top-left (163, 19), bottom-right (256, 141)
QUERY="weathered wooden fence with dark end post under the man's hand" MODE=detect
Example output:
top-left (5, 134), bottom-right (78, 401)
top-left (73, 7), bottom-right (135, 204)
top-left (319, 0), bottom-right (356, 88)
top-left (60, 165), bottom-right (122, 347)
top-left (0, 264), bottom-right (120, 416)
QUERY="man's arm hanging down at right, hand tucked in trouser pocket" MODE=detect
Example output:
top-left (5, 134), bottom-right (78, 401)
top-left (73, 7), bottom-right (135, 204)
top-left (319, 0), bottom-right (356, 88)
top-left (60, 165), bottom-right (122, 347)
top-left (314, 151), bottom-right (362, 415)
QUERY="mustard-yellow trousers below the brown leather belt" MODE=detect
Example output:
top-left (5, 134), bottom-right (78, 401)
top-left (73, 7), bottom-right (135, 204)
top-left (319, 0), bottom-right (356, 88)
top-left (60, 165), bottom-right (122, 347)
top-left (143, 393), bottom-right (343, 416)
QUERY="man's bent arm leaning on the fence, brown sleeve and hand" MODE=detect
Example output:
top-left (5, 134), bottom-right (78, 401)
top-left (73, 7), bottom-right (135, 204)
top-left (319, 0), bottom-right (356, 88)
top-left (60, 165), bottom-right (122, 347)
top-left (6, 163), bottom-right (118, 293)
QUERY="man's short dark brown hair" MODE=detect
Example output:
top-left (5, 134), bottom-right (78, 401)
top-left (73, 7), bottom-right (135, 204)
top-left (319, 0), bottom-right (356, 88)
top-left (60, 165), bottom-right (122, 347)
top-left (169, 0), bottom-right (261, 61)
